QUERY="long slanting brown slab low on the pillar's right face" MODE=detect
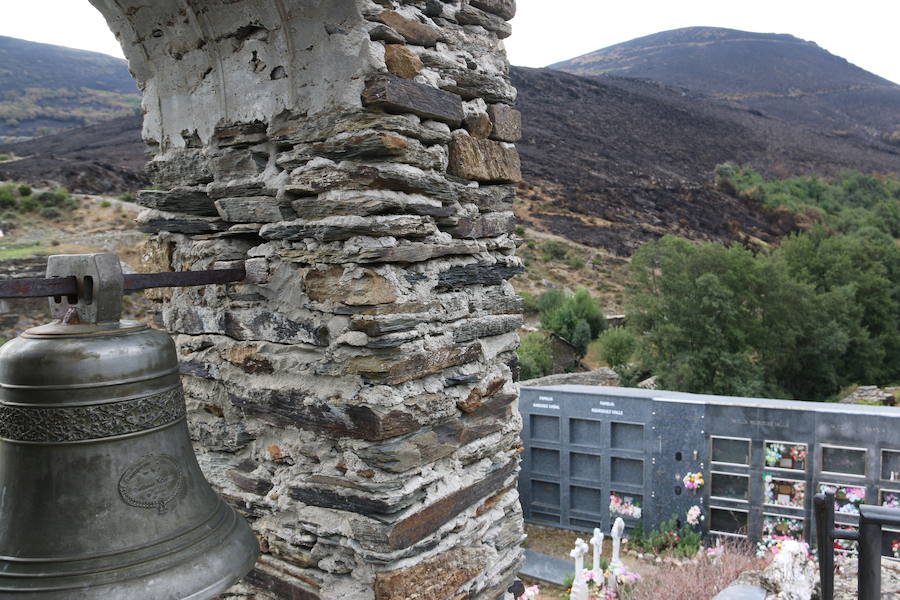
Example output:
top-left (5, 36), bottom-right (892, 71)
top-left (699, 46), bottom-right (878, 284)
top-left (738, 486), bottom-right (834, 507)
top-left (388, 460), bottom-right (518, 550)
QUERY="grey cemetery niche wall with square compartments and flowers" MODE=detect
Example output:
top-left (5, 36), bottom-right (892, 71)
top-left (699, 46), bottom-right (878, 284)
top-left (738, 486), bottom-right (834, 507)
top-left (519, 385), bottom-right (900, 558)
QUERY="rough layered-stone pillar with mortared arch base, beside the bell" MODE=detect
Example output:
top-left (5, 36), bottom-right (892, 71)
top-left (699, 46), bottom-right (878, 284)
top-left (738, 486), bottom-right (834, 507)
top-left (91, 0), bottom-right (523, 600)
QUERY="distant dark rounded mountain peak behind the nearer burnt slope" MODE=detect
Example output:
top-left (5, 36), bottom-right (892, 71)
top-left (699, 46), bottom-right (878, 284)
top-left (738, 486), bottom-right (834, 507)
top-left (551, 27), bottom-right (900, 138)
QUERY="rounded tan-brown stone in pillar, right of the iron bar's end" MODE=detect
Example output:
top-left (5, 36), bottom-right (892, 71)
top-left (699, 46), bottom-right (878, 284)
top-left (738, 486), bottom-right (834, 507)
top-left (303, 266), bottom-right (397, 306)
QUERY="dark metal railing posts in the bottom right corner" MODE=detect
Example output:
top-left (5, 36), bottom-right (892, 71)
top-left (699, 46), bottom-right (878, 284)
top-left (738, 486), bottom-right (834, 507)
top-left (813, 492), bottom-right (900, 600)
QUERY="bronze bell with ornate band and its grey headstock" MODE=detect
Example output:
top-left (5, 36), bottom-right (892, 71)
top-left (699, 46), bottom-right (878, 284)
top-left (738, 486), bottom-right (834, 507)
top-left (0, 254), bottom-right (258, 600)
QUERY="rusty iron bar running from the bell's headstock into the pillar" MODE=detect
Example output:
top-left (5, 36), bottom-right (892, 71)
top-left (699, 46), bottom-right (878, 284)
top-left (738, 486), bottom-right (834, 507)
top-left (0, 269), bottom-right (246, 299)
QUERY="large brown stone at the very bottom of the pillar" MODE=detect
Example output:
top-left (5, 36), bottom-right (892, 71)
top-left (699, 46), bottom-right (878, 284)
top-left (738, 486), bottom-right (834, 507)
top-left (375, 547), bottom-right (489, 600)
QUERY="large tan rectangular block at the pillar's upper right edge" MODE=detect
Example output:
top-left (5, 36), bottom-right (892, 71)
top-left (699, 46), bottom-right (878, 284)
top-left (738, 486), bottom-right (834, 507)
top-left (447, 135), bottom-right (522, 183)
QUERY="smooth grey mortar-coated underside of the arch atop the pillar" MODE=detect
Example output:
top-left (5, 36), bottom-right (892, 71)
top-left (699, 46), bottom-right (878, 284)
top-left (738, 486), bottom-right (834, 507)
top-left (91, 0), bottom-right (377, 151)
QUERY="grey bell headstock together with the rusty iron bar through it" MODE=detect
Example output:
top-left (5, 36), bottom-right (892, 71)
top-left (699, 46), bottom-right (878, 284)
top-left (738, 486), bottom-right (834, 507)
top-left (0, 253), bottom-right (246, 323)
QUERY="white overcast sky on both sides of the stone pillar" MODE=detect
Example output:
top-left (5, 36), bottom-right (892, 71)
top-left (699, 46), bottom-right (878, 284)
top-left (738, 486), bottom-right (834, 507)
top-left (0, 0), bottom-right (900, 83)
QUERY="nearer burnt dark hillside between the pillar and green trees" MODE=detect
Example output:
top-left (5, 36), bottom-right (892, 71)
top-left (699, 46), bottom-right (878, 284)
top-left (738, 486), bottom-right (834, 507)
top-left (512, 68), bottom-right (900, 255)
